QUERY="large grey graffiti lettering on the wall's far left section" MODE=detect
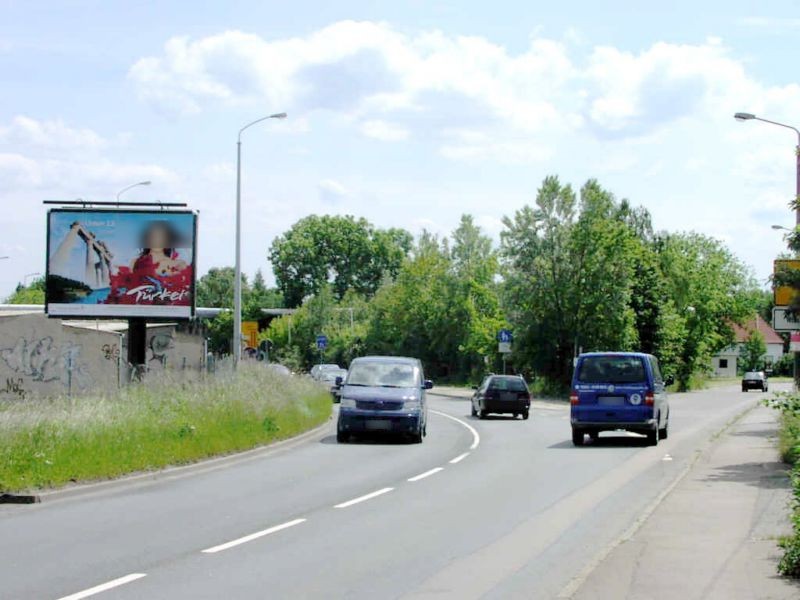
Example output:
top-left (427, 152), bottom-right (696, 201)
top-left (0, 336), bottom-right (91, 391)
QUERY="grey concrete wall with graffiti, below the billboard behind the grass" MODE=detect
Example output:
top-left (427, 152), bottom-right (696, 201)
top-left (0, 314), bottom-right (205, 402)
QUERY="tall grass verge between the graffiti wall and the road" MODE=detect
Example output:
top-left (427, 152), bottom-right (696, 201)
top-left (0, 365), bottom-right (331, 492)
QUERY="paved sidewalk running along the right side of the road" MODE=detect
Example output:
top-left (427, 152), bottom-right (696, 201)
top-left (572, 406), bottom-right (800, 600)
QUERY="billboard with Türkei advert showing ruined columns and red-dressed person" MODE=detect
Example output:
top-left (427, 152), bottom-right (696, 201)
top-left (45, 208), bottom-right (197, 319)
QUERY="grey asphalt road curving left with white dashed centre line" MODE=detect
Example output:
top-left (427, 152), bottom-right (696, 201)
top-left (0, 386), bottom-right (779, 599)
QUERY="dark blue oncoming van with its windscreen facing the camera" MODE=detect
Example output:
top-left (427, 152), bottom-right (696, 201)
top-left (336, 356), bottom-right (433, 443)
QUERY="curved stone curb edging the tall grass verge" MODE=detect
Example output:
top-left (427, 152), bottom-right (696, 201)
top-left (15, 415), bottom-right (333, 504)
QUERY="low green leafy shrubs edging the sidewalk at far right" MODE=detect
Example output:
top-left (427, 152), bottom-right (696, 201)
top-left (766, 394), bottom-right (800, 577)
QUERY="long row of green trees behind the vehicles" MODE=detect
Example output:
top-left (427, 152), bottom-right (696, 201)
top-left (239, 176), bottom-right (766, 388)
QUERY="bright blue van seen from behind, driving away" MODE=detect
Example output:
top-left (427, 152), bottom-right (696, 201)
top-left (569, 352), bottom-right (672, 446)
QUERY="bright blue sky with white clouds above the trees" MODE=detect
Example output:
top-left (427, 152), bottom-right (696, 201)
top-left (0, 0), bottom-right (800, 298)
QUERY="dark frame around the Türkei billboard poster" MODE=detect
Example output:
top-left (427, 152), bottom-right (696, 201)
top-left (44, 203), bottom-right (199, 322)
